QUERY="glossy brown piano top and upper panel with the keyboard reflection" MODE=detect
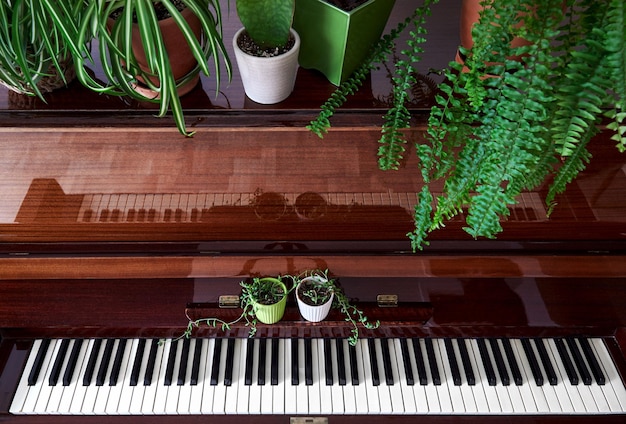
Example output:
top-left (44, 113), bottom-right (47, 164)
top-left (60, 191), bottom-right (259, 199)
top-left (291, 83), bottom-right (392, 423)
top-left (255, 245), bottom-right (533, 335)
top-left (0, 2), bottom-right (626, 254)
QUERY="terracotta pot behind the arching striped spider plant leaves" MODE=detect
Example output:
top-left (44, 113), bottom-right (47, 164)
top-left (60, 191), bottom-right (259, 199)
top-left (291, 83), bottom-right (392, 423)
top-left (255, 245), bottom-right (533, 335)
top-left (127, 9), bottom-right (202, 97)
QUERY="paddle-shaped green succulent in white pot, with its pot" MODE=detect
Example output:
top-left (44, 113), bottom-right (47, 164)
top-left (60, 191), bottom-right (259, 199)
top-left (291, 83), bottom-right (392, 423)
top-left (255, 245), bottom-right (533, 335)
top-left (233, 0), bottom-right (300, 104)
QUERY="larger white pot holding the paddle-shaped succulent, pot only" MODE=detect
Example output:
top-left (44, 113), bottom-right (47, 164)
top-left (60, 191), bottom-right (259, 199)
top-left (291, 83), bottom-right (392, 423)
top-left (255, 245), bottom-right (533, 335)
top-left (233, 28), bottom-right (300, 104)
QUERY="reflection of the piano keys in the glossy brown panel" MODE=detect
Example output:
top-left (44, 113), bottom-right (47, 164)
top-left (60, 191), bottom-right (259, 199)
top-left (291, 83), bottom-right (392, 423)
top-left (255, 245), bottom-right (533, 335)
top-left (78, 192), bottom-right (547, 223)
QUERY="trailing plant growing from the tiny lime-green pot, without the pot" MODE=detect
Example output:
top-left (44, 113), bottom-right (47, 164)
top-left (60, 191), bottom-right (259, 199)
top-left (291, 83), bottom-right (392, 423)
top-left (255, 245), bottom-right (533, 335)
top-left (180, 277), bottom-right (291, 338)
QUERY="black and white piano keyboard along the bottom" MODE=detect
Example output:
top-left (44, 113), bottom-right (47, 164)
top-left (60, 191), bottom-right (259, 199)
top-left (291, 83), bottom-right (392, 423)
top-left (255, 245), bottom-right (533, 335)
top-left (10, 338), bottom-right (626, 415)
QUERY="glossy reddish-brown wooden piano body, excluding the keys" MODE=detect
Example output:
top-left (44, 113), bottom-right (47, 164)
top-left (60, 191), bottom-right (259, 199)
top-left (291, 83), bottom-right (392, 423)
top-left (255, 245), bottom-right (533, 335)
top-left (0, 5), bottom-right (626, 423)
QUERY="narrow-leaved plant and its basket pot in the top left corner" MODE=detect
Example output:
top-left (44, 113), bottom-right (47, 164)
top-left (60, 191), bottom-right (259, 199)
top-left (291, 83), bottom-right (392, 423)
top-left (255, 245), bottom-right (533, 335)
top-left (0, 0), bottom-right (83, 101)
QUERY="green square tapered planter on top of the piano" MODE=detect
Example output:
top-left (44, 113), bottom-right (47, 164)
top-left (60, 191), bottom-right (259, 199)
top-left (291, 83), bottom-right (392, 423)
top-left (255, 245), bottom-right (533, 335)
top-left (293, 0), bottom-right (395, 85)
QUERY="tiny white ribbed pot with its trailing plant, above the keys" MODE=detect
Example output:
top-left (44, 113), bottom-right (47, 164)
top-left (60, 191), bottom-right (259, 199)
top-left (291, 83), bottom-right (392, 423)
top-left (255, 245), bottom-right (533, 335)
top-left (294, 270), bottom-right (380, 346)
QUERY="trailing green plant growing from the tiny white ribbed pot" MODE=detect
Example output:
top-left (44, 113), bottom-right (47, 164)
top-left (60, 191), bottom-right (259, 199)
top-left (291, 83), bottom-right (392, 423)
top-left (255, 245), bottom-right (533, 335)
top-left (294, 270), bottom-right (380, 346)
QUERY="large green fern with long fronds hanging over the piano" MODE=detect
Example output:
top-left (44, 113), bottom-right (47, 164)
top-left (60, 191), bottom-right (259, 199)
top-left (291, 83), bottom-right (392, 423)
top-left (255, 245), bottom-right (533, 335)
top-left (309, 0), bottom-right (626, 250)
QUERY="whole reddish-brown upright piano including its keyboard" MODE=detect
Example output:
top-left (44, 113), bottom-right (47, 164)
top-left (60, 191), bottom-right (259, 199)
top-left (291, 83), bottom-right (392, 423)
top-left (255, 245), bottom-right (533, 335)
top-left (0, 5), bottom-right (626, 424)
